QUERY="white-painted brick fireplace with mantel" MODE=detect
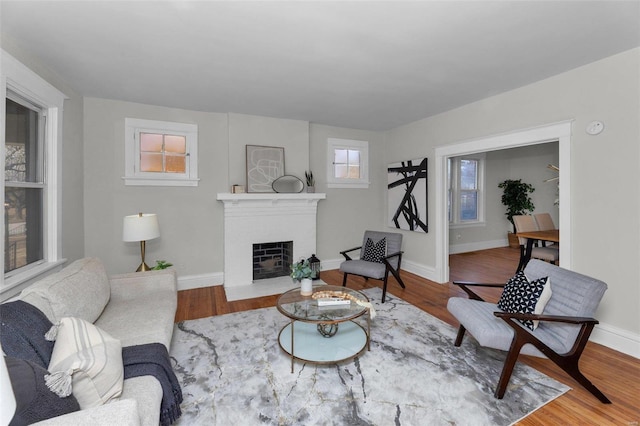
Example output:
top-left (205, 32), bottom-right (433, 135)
top-left (217, 193), bottom-right (326, 300)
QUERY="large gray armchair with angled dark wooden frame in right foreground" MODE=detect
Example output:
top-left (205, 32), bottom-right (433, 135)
top-left (447, 259), bottom-right (611, 404)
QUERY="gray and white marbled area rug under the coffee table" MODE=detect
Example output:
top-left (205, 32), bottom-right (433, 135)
top-left (170, 288), bottom-right (569, 426)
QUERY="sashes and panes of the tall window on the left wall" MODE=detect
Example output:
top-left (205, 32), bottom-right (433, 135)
top-left (4, 91), bottom-right (46, 274)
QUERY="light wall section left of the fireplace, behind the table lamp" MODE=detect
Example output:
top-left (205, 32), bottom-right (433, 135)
top-left (84, 98), bottom-right (229, 276)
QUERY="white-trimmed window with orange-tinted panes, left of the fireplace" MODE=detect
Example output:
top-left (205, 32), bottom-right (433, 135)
top-left (124, 118), bottom-right (199, 186)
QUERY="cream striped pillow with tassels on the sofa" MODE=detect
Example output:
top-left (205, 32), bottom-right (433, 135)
top-left (48, 318), bottom-right (124, 409)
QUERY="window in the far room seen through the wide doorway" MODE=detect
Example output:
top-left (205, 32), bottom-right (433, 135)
top-left (447, 154), bottom-right (485, 227)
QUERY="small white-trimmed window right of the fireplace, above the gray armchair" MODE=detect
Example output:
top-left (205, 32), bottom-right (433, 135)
top-left (327, 138), bottom-right (369, 188)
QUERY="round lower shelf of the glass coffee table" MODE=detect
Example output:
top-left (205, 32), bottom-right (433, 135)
top-left (278, 321), bottom-right (369, 373)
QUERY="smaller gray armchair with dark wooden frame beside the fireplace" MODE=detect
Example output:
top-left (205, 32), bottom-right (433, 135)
top-left (340, 231), bottom-right (405, 303)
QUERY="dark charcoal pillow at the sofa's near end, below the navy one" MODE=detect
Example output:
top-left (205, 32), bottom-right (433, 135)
top-left (5, 357), bottom-right (80, 426)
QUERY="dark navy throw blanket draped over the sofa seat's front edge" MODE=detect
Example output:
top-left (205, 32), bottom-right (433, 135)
top-left (122, 343), bottom-right (182, 426)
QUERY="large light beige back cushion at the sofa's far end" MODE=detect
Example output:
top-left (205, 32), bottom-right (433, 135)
top-left (20, 258), bottom-right (111, 323)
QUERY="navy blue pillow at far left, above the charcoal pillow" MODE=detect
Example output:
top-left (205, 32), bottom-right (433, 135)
top-left (0, 300), bottom-right (54, 369)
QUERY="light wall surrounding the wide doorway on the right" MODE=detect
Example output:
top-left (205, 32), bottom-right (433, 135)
top-left (387, 49), bottom-right (640, 356)
